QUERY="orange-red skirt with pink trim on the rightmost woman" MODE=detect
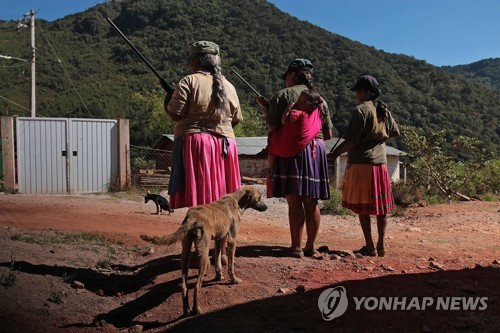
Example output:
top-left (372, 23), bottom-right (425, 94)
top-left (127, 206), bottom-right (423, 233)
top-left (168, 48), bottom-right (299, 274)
top-left (342, 164), bottom-right (394, 215)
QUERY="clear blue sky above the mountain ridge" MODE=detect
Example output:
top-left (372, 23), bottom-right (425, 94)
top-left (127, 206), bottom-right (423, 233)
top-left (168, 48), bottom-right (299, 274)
top-left (0, 0), bottom-right (500, 66)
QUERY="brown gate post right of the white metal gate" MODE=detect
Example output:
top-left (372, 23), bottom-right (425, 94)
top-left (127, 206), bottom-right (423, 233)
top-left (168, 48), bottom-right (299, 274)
top-left (118, 119), bottom-right (131, 191)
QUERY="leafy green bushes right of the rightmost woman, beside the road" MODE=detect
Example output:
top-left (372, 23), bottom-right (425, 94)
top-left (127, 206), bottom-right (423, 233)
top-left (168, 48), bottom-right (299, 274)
top-left (397, 126), bottom-right (500, 204)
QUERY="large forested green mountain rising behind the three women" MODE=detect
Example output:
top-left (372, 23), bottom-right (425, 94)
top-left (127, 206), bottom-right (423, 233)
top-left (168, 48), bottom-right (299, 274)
top-left (0, 0), bottom-right (500, 155)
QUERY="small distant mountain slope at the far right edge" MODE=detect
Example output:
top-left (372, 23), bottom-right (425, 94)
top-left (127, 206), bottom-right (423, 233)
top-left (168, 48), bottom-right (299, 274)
top-left (441, 58), bottom-right (500, 90)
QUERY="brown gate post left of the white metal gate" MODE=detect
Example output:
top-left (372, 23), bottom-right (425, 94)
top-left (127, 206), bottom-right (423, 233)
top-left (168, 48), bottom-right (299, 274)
top-left (0, 116), bottom-right (17, 191)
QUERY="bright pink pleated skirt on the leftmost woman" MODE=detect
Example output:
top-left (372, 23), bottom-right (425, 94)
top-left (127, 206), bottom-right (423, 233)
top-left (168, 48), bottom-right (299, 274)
top-left (170, 133), bottom-right (241, 208)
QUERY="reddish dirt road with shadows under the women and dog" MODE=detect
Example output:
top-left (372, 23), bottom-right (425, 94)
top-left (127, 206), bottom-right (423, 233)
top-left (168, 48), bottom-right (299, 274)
top-left (0, 191), bottom-right (500, 332)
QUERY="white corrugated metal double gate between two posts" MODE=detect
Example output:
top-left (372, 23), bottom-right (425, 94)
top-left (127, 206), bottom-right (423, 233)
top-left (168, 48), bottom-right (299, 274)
top-left (16, 117), bottom-right (118, 194)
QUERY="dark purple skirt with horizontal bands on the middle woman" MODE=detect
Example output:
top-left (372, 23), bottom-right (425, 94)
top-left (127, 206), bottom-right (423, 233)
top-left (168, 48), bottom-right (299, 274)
top-left (272, 139), bottom-right (330, 200)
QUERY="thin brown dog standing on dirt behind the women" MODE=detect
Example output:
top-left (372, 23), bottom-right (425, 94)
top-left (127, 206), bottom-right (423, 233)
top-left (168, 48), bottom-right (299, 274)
top-left (141, 186), bottom-right (267, 316)
